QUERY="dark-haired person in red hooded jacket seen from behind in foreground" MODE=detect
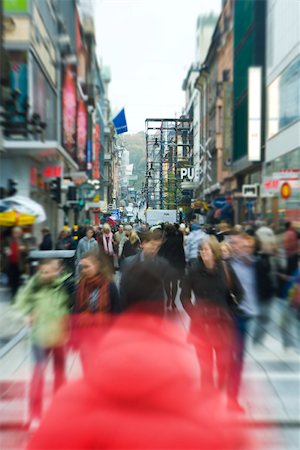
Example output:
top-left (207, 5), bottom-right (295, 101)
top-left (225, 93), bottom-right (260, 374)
top-left (28, 258), bottom-right (254, 450)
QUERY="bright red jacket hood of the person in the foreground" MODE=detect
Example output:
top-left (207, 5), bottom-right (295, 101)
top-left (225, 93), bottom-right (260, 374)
top-left (83, 312), bottom-right (198, 410)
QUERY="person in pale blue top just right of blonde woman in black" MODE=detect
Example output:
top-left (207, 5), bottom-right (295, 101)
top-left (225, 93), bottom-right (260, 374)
top-left (228, 234), bottom-right (259, 412)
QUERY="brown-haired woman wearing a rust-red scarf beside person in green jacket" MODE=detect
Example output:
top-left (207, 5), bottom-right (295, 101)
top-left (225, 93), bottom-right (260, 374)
top-left (71, 251), bottom-right (121, 370)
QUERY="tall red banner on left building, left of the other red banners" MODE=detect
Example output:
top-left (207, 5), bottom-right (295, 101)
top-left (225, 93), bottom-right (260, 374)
top-left (62, 66), bottom-right (76, 156)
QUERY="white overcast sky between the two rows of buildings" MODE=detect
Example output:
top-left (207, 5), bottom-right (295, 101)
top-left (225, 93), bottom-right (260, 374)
top-left (94, 0), bottom-right (221, 133)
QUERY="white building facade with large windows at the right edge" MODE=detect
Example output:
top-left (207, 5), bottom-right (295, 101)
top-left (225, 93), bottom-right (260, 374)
top-left (261, 0), bottom-right (300, 224)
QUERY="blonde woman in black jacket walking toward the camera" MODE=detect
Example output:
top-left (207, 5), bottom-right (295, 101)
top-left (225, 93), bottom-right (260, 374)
top-left (181, 236), bottom-right (239, 394)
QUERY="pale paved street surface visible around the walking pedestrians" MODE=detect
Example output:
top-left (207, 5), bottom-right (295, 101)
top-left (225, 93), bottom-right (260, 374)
top-left (0, 289), bottom-right (300, 450)
